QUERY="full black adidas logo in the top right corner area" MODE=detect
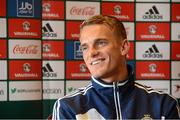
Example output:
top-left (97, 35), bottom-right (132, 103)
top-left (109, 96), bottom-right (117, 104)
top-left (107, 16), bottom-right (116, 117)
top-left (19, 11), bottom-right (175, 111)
top-left (143, 5), bottom-right (163, 19)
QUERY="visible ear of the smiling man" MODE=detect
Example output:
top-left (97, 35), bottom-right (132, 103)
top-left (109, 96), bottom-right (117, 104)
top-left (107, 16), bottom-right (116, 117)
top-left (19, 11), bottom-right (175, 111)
top-left (120, 39), bottom-right (130, 56)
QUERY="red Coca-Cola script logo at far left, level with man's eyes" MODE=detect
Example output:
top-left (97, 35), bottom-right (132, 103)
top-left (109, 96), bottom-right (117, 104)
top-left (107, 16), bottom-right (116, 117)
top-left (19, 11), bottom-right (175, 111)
top-left (13, 44), bottom-right (38, 54)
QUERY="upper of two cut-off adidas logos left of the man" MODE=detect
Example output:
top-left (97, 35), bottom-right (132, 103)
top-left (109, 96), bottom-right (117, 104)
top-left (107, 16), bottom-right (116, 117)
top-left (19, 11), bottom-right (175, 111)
top-left (42, 23), bottom-right (57, 37)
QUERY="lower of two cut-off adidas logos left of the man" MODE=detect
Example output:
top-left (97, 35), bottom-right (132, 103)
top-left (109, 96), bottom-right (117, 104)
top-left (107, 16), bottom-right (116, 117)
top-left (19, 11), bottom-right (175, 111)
top-left (42, 63), bottom-right (57, 78)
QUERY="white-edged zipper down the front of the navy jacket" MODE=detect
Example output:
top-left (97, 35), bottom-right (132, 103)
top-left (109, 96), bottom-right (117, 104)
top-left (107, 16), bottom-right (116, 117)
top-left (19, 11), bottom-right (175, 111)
top-left (113, 82), bottom-right (122, 120)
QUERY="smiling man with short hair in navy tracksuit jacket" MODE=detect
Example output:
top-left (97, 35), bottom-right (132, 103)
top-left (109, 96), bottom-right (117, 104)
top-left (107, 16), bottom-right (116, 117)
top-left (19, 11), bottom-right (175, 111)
top-left (53, 15), bottom-right (180, 120)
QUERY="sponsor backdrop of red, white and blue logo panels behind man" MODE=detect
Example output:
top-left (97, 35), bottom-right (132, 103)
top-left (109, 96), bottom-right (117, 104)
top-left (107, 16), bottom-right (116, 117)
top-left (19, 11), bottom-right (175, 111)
top-left (0, 0), bottom-right (180, 119)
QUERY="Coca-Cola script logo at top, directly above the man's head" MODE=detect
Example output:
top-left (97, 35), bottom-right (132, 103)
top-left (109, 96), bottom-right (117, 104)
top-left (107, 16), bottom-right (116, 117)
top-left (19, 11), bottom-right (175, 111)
top-left (70, 6), bottom-right (95, 15)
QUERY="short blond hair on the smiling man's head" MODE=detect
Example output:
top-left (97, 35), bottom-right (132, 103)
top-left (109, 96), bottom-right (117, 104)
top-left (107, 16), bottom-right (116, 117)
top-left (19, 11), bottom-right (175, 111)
top-left (80, 15), bottom-right (127, 40)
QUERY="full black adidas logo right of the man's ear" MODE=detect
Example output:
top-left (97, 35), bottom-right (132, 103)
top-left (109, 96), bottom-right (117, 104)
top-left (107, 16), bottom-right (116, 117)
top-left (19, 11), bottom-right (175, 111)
top-left (143, 44), bottom-right (163, 58)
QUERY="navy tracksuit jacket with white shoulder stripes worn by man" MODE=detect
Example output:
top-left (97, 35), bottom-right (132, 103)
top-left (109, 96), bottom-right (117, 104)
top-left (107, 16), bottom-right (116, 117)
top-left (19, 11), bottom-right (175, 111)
top-left (53, 66), bottom-right (180, 120)
